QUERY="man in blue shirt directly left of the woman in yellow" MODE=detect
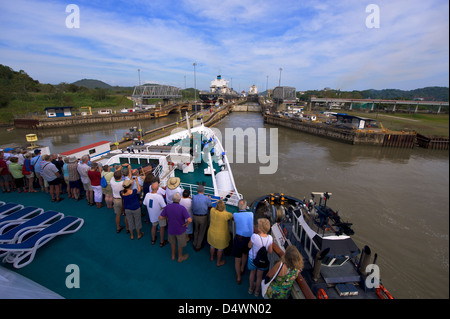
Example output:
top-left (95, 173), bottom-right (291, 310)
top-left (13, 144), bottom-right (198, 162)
top-left (192, 185), bottom-right (212, 251)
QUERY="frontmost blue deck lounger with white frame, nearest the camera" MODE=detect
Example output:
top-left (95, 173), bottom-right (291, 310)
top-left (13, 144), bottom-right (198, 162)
top-left (0, 216), bottom-right (84, 268)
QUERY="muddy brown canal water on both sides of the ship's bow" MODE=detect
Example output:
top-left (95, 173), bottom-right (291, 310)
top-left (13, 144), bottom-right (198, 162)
top-left (0, 112), bottom-right (449, 299)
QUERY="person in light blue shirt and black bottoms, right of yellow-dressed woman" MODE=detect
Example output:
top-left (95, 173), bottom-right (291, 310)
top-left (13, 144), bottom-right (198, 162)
top-left (232, 199), bottom-right (253, 284)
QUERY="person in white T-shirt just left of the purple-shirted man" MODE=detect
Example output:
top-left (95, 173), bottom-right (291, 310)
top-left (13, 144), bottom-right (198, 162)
top-left (142, 182), bottom-right (168, 247)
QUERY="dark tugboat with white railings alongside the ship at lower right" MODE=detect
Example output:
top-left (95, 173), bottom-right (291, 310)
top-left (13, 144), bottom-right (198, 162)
top-left (251, 192), bottom-right (393, 299)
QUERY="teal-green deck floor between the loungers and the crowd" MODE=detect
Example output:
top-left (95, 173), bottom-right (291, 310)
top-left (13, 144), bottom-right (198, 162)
top-left (0, 193), bottom-right (254, 299)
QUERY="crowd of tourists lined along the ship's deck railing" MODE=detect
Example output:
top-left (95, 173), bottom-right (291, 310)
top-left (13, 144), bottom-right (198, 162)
top-left (0, 148), bottom-right (303, 298)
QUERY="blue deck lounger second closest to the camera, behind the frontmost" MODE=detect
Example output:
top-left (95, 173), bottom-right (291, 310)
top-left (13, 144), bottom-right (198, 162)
top-left (0, 211), bottom-right (64, 246)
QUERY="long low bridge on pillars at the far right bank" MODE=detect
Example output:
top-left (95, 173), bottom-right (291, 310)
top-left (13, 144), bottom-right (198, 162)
top-left (310, 97), bottom-right (449, 113)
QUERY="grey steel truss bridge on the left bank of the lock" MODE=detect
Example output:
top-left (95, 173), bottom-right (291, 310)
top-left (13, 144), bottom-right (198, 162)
top-left (131, 84), bottom-right (181, 106)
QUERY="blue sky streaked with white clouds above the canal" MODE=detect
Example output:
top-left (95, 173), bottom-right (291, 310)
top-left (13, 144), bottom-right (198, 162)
top-left (0, 0), bottom-right (449, 91)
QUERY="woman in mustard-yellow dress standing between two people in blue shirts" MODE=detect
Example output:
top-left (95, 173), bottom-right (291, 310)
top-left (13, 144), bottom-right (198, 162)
top-left (207, 200), bottom-right (233, 267)
